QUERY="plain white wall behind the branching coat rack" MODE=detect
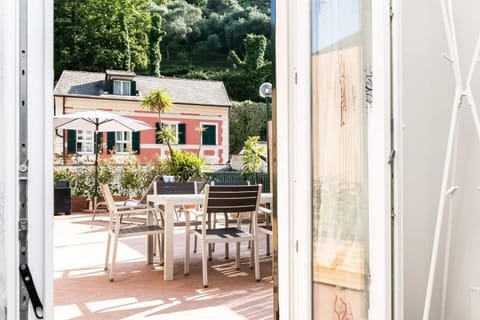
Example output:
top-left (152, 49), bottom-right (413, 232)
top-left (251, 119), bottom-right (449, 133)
top-left (400, 0), bottom-right (480, 319)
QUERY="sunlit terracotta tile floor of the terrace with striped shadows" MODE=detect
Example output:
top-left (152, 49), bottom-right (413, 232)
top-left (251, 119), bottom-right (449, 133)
top-left (54, 213), bottom-right (273, 320)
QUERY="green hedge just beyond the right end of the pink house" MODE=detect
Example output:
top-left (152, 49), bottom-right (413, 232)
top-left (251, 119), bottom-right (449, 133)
top-left (229, 101), bottom-right (267, 154)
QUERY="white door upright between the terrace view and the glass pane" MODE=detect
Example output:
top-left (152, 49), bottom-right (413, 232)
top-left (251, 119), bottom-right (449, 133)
top-left (275, 0), bottom-right (312, 319)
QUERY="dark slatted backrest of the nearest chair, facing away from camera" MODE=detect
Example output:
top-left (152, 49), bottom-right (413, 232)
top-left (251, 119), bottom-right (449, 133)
top-left (205, 185), bottom-right (262, 213)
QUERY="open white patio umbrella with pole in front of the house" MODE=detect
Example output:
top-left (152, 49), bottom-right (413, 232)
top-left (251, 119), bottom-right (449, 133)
top-left (53, 111), bottom-right (154, 195)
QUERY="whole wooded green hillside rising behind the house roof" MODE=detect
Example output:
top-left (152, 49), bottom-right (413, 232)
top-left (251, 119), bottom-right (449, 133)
top-left (54, 0), bottom-right (273, 101)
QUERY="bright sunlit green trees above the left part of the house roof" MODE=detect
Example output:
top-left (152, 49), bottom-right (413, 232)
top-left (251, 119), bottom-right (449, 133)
top-left (54, 0), bottom-right (150, 78)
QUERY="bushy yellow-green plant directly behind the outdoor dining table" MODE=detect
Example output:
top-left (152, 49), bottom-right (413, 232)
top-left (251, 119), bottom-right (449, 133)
top-left (160, 149), bottom-right (205, 182)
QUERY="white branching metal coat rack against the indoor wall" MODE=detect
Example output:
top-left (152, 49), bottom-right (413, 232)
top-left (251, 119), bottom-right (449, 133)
top-left (423, 0), bottom-right (480, 320)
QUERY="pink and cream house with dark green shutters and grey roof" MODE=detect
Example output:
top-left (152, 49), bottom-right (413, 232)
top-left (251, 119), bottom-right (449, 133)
top-left (54, 70), bottom-right (231, 165)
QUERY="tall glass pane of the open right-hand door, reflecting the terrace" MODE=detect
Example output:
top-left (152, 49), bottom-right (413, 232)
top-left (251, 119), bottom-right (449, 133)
top-left (311, 0), bottom-right (370, 320)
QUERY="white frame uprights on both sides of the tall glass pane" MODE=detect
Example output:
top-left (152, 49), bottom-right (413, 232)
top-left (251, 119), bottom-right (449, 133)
top-left (275, 0), bottom-right (394, 320)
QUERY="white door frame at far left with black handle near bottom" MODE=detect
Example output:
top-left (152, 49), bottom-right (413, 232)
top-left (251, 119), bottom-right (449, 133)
top-left (0, 0), bottom-right (53, 320)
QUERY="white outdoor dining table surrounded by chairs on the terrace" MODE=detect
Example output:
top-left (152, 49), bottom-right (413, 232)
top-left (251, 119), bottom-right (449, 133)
top-left (147, 193), bottom-right (272, 280)
